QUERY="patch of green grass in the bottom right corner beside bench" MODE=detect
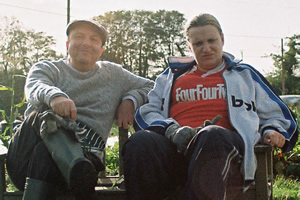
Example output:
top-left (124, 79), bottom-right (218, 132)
top-left (273, 176), bottom-right (300, 200)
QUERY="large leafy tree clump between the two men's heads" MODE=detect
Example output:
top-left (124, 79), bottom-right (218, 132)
top-left (94, 10), bottom-right (188, 79)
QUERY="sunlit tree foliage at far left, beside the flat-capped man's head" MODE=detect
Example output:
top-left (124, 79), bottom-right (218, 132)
top-left (0, 18), bottom-right (59, 74)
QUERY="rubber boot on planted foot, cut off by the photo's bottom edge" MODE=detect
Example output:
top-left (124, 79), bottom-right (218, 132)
top-left (22, 178), bottom-right (57, 200)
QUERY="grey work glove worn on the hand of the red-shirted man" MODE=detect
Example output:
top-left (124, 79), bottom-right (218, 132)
top-left (165, 124), bottom-right (196, 153)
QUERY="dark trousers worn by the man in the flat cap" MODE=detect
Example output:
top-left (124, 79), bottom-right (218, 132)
top-left (6, 109), bottom-right (103, 190)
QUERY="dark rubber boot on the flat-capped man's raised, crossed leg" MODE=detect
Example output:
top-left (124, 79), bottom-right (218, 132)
top-left (41, 128), bottom-right (97, 197)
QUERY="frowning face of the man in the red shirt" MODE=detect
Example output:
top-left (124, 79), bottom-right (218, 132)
top-left (188, 25), bottom-right (224, 71)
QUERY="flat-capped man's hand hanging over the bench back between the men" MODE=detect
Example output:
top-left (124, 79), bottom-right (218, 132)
top-left (117, 99), bottom-right (135, 129)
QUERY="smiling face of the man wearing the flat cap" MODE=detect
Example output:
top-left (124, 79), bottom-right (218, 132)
top-left (67, 23), bottom-right (104, 72)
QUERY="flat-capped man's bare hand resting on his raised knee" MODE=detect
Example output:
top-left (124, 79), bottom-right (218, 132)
top-left (50, 96), bottom-right (77, 121)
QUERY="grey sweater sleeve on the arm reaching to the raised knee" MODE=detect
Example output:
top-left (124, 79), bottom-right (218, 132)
top-left (25, 61), bottom-right (68, 106)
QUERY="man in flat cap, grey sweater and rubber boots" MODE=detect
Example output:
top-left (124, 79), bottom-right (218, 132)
top-left (7, 20), bottom-right (153, 200)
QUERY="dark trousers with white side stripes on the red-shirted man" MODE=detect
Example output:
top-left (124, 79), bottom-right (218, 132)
top-left (123, 126), bottom-right (244, 200)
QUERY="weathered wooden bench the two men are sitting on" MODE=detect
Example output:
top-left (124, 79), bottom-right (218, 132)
top-left (0, 128), bottom-right (273, 200)
